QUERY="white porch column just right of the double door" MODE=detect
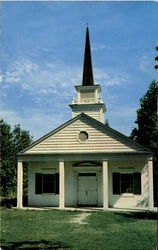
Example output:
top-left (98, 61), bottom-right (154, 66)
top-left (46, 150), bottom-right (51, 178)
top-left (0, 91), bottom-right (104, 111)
top-left (103, 161), bottom-right (109, 210)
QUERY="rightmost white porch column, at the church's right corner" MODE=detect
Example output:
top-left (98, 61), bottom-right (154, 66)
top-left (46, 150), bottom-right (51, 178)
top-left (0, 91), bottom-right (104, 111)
top-left (148, 160), bottom-right (154, 210)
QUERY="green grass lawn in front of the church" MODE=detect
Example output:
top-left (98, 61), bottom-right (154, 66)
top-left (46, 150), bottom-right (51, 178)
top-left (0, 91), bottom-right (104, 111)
top-left (1, 209), bottom-right (157, 250)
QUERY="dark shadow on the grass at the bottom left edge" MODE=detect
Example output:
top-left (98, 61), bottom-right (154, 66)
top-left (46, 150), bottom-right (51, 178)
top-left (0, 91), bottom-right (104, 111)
top-left (1, 240), bottom-right (71, 250)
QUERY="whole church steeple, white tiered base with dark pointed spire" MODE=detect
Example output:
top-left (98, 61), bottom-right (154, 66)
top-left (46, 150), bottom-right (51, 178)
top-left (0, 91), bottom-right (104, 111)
top-left (69, 27), bottom-right (106, 123)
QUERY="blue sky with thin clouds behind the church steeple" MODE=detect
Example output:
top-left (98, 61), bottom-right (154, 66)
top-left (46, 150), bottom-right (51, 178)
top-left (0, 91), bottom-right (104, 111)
top-left (1, 2), bottom-right (158, 139)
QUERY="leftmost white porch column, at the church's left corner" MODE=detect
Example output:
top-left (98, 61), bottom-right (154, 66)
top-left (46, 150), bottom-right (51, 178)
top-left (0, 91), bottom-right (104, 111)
top-left (17, 161), bottom-right (23, 208)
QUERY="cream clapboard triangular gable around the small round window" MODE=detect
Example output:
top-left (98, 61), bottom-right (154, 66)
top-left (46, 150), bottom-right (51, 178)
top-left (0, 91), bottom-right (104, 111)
top-left (21, 113), bottom-right (149, 154)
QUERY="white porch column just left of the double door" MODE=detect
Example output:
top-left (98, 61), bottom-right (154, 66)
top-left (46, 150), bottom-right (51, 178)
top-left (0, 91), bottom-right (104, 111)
top-left (59, 161), bottom-right (65, 209)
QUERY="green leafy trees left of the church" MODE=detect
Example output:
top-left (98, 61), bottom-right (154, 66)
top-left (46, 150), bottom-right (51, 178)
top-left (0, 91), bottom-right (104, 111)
top-left (0, 120), bottom-right (32, 197)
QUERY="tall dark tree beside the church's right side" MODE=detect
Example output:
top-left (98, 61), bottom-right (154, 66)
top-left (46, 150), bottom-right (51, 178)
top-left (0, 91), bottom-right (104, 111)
top-left (130, 81), bottom-right (158, 206)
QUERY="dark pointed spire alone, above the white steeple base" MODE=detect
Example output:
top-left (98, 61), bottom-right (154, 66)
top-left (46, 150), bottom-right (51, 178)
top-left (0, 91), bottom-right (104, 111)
top-left (82, 26), bottom-right (94, 86)
